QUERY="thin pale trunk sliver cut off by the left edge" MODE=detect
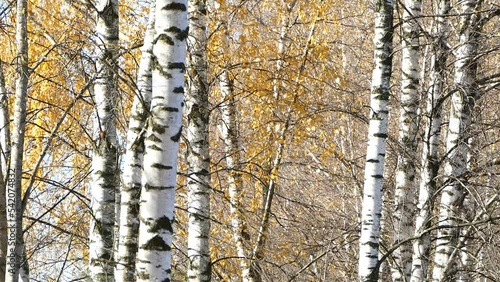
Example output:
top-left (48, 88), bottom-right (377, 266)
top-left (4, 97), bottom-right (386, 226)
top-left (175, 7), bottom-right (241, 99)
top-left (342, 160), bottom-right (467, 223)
top-left (0, 62), bottom-right (10, 282)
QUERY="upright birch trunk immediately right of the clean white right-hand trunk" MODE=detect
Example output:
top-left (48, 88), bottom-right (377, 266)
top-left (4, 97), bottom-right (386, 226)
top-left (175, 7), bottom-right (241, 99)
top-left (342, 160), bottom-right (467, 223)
top-left (391, 0), bottom-right (422, 282)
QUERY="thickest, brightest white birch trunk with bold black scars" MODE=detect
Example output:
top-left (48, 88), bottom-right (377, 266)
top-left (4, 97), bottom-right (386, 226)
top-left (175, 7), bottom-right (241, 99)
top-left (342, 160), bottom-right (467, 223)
top-left (136, 0), bottom-right (188, 281)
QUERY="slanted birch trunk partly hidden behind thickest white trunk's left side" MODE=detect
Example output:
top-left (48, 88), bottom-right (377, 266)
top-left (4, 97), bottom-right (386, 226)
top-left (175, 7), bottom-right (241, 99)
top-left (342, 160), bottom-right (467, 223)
top-left (115, 2), bottom-right (155, 282)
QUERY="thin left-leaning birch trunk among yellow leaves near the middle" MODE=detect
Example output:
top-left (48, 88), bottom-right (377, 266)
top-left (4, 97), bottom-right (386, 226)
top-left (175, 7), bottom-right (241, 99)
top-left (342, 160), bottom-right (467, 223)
top-left (219, 20), bottom-right (255, 282)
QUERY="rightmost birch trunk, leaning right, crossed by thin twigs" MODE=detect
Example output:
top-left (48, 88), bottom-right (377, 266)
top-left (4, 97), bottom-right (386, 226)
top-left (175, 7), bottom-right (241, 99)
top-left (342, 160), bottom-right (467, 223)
top-left (432, 0), bottom-right (481, 281)
